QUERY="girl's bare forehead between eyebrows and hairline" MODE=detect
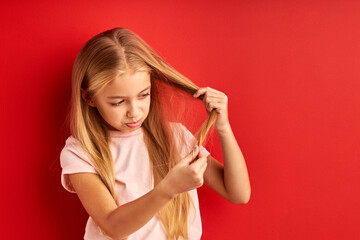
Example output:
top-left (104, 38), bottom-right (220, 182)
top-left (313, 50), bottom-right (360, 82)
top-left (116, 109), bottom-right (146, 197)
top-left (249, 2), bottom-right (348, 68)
top-left (102, 72), bottom-right (150, 97)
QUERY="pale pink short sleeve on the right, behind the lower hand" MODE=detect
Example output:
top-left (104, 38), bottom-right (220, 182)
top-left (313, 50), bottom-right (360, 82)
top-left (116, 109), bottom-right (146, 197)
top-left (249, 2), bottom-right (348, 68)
top-left (170, 123), bottom-right (210, 157)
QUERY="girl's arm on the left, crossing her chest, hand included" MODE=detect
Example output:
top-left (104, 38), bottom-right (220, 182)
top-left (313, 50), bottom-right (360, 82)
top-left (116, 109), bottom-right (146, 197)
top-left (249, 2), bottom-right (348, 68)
top-left (69, 145), bottom-right (206, 239)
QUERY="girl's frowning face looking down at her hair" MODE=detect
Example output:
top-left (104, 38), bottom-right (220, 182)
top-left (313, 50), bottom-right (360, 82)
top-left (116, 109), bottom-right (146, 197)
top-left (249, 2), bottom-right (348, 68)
top-left (90, 72), bottom-right (151, 132)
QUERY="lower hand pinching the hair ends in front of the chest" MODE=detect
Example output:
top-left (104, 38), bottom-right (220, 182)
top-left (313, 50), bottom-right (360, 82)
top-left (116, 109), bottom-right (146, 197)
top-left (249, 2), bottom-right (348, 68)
top-left (162, 146), bottom-right (207, 198)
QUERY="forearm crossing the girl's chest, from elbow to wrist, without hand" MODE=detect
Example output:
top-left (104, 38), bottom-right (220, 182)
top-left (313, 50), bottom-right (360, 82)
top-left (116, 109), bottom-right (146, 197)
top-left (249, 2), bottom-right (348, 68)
top-left (107, 182), bottom-right (172, 239)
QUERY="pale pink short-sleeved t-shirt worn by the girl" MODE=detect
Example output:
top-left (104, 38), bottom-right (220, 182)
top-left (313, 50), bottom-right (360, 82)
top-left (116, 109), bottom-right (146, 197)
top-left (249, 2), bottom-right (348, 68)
top-left (60, 123), bottom-right (209, 240)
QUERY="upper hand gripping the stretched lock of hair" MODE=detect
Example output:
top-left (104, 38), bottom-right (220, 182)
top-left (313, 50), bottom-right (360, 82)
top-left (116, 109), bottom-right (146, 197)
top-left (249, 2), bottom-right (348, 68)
top-left (193, 87), bottom-right (230, 134)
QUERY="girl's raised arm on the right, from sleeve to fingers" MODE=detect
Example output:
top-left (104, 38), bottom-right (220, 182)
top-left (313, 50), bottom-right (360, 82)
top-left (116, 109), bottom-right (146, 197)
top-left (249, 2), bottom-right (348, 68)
top-left (194, 88), bottom-right (251, 204)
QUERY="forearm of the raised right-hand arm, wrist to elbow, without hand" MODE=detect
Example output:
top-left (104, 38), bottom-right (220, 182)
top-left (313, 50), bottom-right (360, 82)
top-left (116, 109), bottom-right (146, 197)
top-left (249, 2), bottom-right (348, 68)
top-left (218, 125), bottom-right (251, 203)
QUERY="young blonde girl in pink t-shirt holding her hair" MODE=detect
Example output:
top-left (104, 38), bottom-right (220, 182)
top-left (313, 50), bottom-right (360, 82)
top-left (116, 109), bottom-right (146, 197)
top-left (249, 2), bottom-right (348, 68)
top-left (60, 28), bottom-right (250, 240)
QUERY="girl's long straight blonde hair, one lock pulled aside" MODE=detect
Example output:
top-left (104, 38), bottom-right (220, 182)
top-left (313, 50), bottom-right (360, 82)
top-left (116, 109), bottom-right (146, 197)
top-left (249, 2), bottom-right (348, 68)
top-left (70, 28), bottom-right (216, 239)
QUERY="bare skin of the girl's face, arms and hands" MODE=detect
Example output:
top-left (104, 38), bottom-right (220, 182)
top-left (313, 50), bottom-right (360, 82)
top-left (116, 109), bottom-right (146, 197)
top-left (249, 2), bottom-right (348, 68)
top-left (69, 72), bottom-right (251, 239)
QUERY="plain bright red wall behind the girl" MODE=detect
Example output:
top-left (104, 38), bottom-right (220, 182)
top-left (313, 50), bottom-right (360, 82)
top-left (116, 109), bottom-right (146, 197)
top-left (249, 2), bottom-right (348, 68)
top-left (0, 0), bottom-right (360, 240)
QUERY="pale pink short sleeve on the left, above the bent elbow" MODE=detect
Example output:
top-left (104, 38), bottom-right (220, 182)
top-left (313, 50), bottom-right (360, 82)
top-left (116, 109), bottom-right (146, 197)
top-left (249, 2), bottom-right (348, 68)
top-left (60, 137), bottom-right (97, 193)
